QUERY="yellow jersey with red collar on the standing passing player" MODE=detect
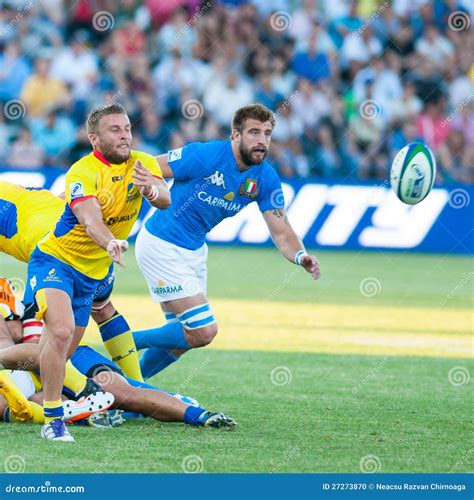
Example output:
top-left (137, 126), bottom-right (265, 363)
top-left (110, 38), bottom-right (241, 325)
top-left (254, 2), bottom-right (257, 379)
top-left (38, 151), bottom-right (162, 279)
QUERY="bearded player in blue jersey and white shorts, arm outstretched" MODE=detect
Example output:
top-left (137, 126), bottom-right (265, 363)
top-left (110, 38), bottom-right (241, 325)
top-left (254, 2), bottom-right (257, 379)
top-left (134, 104), bottom-right (320, 378)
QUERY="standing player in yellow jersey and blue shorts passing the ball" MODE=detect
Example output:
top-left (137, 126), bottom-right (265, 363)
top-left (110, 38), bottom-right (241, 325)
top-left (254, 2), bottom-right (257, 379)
top-left (25, 104), bottom-right (170, 441)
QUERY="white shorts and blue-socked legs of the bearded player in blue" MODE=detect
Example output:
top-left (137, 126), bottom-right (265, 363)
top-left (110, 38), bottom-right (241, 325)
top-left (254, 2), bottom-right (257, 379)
top-left (134, 230), bottom-right (217, 378)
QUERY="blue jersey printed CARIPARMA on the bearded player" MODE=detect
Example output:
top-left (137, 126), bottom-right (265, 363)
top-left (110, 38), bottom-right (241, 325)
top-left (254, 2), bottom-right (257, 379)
top-left (145, 141), bottom-right (284, 250)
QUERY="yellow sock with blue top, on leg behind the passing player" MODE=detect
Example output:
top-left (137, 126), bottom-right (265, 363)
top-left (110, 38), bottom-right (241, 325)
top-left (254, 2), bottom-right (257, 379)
top-left (99, 314), bottom-right (143, 382)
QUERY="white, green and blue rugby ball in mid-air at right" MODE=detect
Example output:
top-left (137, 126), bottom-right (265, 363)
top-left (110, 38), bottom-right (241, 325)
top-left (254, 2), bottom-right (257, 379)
top-left (390, 142), bottom-right (436, 205)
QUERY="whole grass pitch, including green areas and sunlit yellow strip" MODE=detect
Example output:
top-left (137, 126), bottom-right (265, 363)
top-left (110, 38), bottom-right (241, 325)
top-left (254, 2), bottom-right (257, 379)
top-left (0, 247), bottom-right (474, 472)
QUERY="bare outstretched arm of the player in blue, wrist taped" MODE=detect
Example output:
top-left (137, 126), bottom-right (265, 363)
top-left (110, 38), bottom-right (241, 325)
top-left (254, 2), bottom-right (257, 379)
top-left (263, 208), bottom-right (321, 280)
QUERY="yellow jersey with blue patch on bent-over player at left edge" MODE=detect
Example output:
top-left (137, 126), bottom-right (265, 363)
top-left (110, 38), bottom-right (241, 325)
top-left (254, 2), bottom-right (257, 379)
top-left (0, 181), bottom-right (64, 262)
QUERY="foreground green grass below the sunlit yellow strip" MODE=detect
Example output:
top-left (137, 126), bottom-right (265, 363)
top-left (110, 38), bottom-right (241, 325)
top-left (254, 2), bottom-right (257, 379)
top-left (0, 350), bottom-right (473, 472)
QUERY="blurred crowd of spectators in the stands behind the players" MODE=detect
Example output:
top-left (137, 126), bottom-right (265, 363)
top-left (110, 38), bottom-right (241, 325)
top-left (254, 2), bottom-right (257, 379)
top-left (0, 0), bottom-right (474, 183)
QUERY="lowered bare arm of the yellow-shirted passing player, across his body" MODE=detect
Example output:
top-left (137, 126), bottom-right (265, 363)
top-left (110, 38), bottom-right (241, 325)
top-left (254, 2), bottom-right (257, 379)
top-left (71, 197), bottom-right (128, 267)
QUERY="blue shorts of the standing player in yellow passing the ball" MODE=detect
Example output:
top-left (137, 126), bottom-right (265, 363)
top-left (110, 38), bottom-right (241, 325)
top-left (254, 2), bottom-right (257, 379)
top-left (23, 247), bottom-right (101, 326)
